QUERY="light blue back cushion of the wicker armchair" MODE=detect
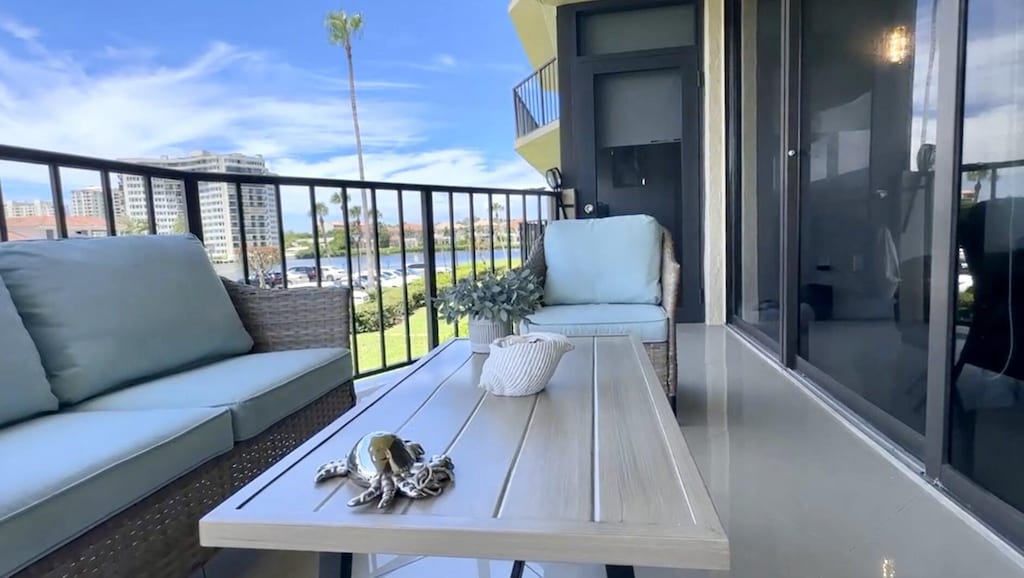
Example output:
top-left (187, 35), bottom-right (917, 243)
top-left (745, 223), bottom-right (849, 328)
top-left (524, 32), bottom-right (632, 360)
top-left (544, 215), bottom-right (662, 305)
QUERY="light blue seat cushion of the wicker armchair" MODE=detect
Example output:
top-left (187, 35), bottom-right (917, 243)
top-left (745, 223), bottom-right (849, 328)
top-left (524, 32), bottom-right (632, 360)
top-left (523, 304), bottom-right (669, 343)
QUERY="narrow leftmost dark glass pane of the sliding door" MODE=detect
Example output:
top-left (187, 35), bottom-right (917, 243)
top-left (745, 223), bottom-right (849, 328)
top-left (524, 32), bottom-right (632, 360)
top-left (734, 0), bottom-right (782, 341)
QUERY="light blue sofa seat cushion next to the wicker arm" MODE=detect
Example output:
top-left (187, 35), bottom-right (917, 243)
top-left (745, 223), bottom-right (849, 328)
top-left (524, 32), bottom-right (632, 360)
top-left (74, 348), bottom-right (352, 441)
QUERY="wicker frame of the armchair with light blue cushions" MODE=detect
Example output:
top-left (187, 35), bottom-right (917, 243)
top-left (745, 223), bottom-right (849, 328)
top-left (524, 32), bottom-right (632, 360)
top-left (523, 226), bottom-right (680, 401)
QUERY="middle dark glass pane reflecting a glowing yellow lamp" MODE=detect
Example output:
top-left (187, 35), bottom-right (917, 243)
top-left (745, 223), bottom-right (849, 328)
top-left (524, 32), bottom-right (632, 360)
top-left (799, 0), bottom-right (938, 436)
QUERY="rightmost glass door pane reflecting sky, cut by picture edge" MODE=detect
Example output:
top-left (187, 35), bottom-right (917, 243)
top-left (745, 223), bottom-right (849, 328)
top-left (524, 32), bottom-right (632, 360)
top-left (949, 0), bottom-right (1024, 509)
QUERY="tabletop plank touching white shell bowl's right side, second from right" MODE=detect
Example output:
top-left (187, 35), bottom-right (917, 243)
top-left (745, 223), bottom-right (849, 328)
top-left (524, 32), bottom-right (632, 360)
top-left (498, 338), bottom-right (594, 522)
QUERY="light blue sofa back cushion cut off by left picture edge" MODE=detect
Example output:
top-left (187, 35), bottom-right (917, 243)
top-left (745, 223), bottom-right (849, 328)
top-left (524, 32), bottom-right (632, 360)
top-left (0, 277), bottom-right (57, 426)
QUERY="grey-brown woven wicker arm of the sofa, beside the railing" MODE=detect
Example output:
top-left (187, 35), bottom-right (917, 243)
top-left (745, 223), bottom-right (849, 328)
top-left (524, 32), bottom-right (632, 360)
top-left (221, 279), bottom-right (350, 353)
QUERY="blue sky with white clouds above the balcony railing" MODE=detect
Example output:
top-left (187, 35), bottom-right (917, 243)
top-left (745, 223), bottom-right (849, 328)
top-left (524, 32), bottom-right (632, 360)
top-left (0, 0), bottom-right (543, 230)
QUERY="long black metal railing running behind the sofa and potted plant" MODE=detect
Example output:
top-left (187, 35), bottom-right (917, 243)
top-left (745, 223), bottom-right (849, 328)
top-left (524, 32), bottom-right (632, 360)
top-left (0, 146), bottom-right (562, 376)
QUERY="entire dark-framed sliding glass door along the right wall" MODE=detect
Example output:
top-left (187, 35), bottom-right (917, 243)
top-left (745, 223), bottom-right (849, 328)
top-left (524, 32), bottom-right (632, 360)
top-left (729, 0), bottom-right (1024, 546)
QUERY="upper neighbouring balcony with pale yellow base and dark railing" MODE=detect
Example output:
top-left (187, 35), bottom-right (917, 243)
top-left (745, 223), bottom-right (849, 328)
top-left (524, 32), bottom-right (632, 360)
top-left (512, 60), bottom-right (561, 172)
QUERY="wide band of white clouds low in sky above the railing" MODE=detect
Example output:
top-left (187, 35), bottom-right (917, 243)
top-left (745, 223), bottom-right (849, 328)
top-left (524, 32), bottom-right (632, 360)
top-left (0, 27), bottom-right (543, 214)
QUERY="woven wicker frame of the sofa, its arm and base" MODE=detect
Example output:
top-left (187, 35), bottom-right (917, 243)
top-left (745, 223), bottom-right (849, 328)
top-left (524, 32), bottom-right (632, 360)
top-left (14, 280), bottom-right (355, 578)
